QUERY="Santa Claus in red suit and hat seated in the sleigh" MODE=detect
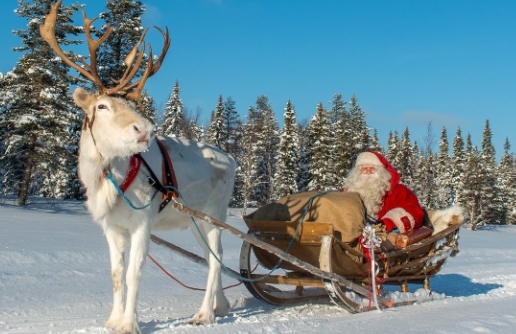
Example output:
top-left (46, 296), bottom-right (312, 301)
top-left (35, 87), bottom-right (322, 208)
top-left (343, 151), bottom-right (424, 233)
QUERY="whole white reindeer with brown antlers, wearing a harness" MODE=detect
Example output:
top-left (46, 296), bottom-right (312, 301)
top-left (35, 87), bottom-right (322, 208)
top-left (40, 0), bottom-right (236, 333)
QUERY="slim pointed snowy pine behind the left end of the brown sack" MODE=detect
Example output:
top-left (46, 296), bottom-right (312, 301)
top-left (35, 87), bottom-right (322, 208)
top-left (274, 100), bottom-right (300, 199)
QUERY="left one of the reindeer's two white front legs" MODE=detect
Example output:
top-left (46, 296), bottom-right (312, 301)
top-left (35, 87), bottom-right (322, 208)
top-left (104, 224), bottom-right (129, 328)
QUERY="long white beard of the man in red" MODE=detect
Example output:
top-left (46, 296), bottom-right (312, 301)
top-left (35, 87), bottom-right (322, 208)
top-left (346, 172), bottom-right (390, 219)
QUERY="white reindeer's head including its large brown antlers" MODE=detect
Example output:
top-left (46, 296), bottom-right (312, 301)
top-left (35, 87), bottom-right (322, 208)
top-left (40, 0), bottom-right (170, 158)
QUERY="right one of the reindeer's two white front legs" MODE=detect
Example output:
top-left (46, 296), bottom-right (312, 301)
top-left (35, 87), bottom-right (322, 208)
top-left (115, 224), bottom-right (150, 334)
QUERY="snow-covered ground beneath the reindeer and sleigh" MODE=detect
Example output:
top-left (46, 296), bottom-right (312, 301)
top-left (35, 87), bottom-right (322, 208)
top-left (0, 199), bottom-right (516, 334)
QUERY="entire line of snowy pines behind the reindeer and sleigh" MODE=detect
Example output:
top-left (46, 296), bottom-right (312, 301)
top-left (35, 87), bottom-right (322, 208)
top-left (0, 0), bottom-right (516, 228)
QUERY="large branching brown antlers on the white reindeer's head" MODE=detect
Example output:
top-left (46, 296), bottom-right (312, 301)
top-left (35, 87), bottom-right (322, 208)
top-left (40, 0), bottom-right (170, 107)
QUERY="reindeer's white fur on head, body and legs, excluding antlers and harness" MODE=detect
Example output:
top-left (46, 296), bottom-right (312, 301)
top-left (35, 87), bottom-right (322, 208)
top-left (73, 88), bottom-right (236, 334)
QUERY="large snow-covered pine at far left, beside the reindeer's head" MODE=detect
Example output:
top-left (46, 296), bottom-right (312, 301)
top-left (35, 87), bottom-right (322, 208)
top-left (0, 0), bottom-right (81, 206)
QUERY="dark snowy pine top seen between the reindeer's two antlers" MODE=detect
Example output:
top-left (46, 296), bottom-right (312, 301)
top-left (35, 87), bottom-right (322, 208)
top-left (96, 0), bottom-right (145, 87)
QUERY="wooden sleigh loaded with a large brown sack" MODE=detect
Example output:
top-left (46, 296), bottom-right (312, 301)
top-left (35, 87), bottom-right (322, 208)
top-left (240, 192), bottom-right (464, 313)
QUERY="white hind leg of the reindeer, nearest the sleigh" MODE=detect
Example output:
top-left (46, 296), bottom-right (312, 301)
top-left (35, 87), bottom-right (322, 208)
top-left (189, 222), bottom-right (230, 325)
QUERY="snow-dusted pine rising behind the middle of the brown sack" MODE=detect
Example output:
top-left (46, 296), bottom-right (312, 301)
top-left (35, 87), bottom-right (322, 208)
top-left (308, 103), bottom-right (336, 191)
